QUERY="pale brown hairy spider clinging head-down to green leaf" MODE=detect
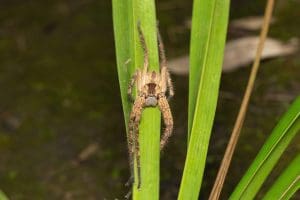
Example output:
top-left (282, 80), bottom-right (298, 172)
top-left (128, 23), bottom-right (174, 189)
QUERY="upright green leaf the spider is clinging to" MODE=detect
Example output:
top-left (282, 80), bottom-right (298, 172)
top-left (112, 0), bottom-right (160, 200)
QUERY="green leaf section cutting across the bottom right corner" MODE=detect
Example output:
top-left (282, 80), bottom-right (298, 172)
top-left (263, 154), bottom-right (300, 200)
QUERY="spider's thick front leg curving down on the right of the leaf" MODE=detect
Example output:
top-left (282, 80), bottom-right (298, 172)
top-left (158, 94), bottom-right (173, 150)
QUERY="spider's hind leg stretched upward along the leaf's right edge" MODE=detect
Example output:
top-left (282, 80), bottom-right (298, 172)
top-left (157, 28), bottom-right (174, 99)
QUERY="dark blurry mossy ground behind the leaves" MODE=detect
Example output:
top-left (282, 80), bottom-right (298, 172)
top-left (0, 0), bottom-right (300, 200)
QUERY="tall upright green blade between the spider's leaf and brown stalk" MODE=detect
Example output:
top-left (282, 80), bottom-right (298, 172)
top-left (178, 0), bottom-right (229, 199)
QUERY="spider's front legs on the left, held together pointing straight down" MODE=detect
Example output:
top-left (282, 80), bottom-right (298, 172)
top-left (128, 96), bottom-right (145, 188)
